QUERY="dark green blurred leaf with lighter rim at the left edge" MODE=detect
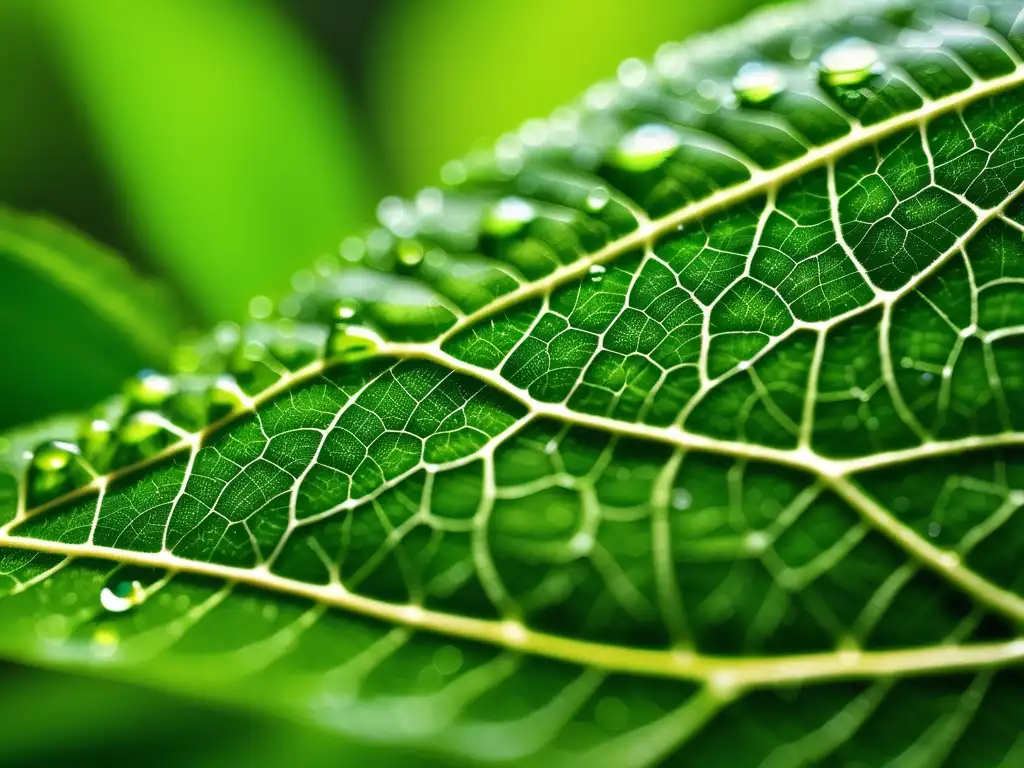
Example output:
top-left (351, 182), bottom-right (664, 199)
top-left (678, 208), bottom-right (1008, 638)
top-left (0, 209), bottom-right (180, 427)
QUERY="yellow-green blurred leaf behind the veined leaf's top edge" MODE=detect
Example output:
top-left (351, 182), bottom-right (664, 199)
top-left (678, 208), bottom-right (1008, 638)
top-left (370, 0), bottom-right (764, 194)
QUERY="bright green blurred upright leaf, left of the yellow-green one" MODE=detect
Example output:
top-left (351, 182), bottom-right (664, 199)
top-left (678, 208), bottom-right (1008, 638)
top-left (32, 0), bottom-right (375, 319)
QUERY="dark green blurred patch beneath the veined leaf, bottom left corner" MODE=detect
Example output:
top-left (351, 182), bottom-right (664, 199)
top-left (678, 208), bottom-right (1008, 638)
top-left (0, 666), bottom-right (446, 768)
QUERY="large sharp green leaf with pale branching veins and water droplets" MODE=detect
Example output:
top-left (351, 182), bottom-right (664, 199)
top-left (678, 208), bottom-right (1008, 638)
top-left (0, 0), bottom-right (1024, 766)
